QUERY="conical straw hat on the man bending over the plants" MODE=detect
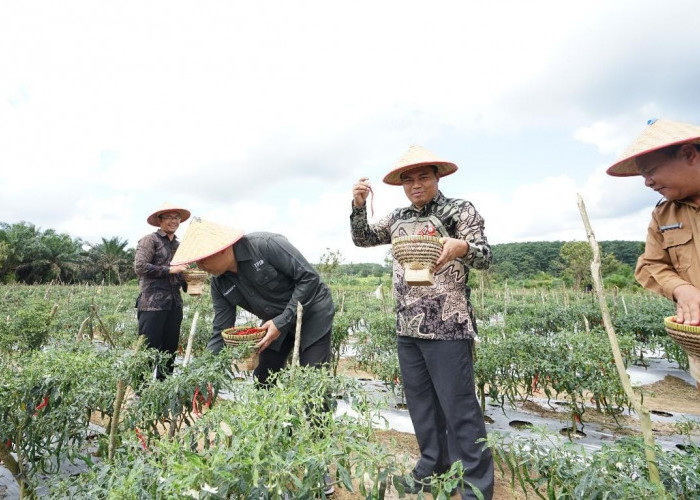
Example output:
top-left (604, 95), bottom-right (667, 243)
top-left (170, 217), bottom-right (243, 266)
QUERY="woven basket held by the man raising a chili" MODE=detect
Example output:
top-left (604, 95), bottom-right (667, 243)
top-left (391, 235), bottom-right (442, 286)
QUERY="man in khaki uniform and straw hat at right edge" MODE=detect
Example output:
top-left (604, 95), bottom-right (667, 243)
top-left (607, 120), bottom-right (700, 391)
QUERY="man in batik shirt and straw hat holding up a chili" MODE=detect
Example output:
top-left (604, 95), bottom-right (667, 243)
top-left (350, 146), bottom-right (493, 498)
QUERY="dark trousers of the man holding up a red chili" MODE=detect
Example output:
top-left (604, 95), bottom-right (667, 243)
top-left (398, 336), bottom-right (493, 499)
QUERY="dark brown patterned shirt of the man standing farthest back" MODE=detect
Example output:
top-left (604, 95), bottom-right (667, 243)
top-left (134, 229), bottom-right (185, 311)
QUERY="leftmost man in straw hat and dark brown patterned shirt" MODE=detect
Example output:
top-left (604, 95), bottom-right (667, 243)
top-left (134, 203), bottom-right (190, 380)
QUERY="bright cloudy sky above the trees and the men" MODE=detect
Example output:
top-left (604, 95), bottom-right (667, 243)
top-left (0, 0), bottom-right (700, 263)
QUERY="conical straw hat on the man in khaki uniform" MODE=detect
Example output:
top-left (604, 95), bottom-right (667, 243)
top-left (607, 120), bottom-right (700, 177)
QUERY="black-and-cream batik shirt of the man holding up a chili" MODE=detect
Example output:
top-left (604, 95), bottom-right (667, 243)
top-left (350, 192), bottom-right (492, 340)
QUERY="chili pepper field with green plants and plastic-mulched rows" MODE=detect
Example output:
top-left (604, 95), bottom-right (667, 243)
top-left (0, 277), bottom-right (700, 499)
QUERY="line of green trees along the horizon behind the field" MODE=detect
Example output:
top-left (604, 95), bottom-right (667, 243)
top-left (0, 222), bottom-right (644, 288)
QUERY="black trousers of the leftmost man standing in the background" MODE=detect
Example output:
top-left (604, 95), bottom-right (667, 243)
top-left (136, 307), bottom-right (182, 380)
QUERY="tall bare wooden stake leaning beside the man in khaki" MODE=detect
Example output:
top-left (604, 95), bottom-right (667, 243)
top-left (578, 194), bottom-right (665, 490)
